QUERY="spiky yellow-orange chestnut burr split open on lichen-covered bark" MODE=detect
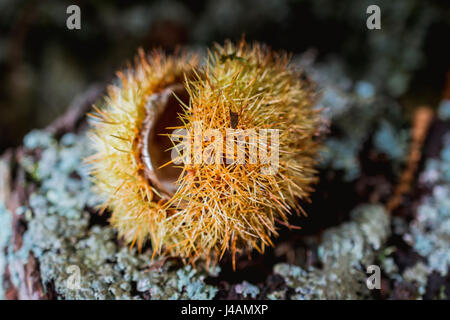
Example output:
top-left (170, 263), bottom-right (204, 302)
top-left (89, 41), bottom-right (320, 263)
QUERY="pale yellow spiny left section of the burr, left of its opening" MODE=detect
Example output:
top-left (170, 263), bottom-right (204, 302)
top-left (87, 51), bottom-right (197, 252)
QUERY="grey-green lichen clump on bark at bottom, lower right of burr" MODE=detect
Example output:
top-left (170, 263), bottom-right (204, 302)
top-left (269, 205), bottom-right (390, 300)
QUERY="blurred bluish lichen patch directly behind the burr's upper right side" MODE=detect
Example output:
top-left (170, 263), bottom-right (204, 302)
top-left (310, 59), bottom-right (409, 182)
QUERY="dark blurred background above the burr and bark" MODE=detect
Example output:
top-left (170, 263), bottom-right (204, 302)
top-left (0, 0), bottom-right (450, 152)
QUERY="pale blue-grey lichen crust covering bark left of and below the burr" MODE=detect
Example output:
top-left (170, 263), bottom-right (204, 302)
top-left (0, 131), bottom-right (218, 299)
